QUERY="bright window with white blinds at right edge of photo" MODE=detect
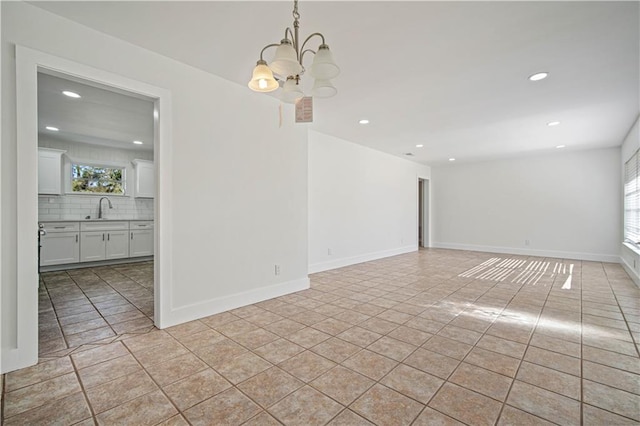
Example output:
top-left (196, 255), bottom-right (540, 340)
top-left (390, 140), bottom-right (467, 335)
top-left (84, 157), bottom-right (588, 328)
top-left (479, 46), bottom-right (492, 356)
top-left (624, 150), bottom-right (640, 244)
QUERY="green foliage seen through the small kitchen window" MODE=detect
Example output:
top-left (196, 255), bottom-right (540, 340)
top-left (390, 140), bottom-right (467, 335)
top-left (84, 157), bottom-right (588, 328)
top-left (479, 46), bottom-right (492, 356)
top-left (71, 164), bottom-right (124, 195)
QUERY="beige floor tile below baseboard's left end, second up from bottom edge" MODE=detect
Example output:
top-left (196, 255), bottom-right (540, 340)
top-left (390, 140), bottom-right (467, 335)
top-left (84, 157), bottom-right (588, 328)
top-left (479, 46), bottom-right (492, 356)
top-left (163, 368), bottom-right (231, 411)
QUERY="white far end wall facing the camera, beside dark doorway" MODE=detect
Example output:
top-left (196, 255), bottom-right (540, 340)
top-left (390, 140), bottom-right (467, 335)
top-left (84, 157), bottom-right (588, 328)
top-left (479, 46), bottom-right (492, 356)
top-left (431, 148), bottom-right (621, 262)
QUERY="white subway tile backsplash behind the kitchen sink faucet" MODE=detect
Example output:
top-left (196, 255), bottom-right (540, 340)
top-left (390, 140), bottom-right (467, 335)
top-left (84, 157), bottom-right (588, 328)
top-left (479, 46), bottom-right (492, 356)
top-left (38, 195), bottom-right (153, 220)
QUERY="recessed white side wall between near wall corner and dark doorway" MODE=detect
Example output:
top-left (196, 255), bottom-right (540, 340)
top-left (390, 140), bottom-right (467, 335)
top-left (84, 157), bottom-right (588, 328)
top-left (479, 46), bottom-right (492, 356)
top-left (309, 131), bottom-right (430, 272)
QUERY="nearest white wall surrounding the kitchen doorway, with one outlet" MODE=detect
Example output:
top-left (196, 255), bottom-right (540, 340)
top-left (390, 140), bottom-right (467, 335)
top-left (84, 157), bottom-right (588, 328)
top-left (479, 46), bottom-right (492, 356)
top-left (0, 2), bottom-right (308, 371)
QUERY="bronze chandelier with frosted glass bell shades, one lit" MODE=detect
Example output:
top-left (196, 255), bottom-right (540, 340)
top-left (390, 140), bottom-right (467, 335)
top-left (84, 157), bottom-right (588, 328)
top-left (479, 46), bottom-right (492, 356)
top-left (249, 0), bottom-right (340, 103)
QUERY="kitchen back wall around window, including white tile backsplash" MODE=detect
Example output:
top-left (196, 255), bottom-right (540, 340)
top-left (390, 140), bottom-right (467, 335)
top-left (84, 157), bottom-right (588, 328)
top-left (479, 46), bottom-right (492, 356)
top-left (38, 135), bottom-right (153, 220)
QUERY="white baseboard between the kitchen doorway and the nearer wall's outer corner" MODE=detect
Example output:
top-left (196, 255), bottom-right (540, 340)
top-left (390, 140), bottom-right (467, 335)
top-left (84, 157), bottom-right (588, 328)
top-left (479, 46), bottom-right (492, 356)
top-left (162, 277), bottom-right (310, 328)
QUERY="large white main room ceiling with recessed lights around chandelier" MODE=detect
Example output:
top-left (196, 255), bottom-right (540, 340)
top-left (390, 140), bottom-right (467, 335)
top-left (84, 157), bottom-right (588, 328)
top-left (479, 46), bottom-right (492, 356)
top-left (33, 0), bottom-right (640, 164)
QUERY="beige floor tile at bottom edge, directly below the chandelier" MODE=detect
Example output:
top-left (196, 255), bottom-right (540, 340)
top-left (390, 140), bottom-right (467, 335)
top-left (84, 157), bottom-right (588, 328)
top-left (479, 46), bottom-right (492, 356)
top-left (269, 386), bottom-right (343, 426)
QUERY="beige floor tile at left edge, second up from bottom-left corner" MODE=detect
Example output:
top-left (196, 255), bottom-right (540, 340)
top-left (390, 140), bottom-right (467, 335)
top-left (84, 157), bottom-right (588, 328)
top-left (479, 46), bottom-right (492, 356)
top-left (3, 373), bottom-right (81, 417)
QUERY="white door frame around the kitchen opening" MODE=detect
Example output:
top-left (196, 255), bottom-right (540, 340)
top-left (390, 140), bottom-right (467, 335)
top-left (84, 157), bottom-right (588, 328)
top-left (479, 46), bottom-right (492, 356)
top-left (10, 45), bottom-right (173, 372)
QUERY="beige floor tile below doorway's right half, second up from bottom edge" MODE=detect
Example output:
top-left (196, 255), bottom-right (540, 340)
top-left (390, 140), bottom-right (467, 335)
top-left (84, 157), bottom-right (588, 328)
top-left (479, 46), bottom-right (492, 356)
top-left (86, 371), bottom-right (158, 413)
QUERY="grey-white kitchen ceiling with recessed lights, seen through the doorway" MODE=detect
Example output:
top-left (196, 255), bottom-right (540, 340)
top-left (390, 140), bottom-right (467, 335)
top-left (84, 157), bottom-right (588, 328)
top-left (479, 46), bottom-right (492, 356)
top-left (38, 72), bottom-right (154, 151)
